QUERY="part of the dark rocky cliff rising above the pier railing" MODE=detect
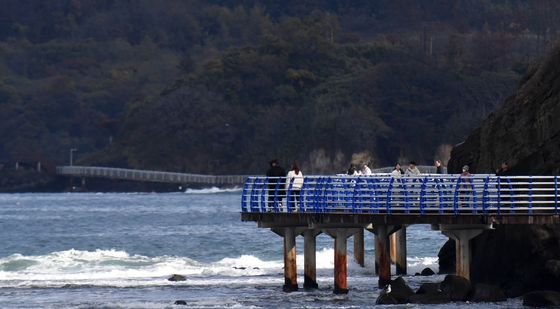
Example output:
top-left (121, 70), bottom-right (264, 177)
top-left (448, 46), bottom-right (560, 175)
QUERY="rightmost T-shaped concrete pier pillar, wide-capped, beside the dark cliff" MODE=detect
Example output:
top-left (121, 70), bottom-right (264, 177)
top-left (440, 225), bottom-right (490, 280)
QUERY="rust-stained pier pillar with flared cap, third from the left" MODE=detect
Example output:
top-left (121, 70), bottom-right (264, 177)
top-left (325, 228), bottom-right (358, 294)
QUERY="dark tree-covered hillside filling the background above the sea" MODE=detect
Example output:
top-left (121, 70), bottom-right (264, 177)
top-left (0, 0), bottom-right (560, 173)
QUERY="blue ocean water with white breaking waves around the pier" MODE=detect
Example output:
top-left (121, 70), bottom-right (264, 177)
top-left (0, 188), bottom-right (522, 308)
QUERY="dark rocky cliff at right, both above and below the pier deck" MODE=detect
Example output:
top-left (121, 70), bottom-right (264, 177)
top-left (440, 46), bottom-right (560, 296)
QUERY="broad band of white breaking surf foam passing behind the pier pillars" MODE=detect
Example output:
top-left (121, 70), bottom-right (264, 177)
top-left (0, 248), bottom-right (437, 287)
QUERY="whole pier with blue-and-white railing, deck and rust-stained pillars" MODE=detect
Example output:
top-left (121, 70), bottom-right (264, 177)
top-left (241, 174), bottom-right (560, 293)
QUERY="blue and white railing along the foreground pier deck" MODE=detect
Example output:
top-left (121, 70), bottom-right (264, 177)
top-left (241, 174), bottom-right (558, 215)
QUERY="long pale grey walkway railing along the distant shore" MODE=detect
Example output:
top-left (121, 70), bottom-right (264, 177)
top-left (56, 166), bottom-right (247, 185)
